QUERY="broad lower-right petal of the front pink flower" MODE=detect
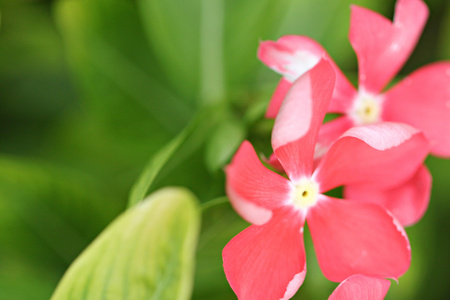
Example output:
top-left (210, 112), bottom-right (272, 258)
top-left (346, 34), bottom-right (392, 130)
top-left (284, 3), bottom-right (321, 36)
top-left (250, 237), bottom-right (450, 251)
top-left (306, 196), bottom-right (411, 282)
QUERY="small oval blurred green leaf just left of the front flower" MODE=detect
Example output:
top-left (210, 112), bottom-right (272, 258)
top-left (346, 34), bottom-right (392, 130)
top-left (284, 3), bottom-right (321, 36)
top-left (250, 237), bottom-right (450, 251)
top-left (205, 120), bottom-right (246, 172)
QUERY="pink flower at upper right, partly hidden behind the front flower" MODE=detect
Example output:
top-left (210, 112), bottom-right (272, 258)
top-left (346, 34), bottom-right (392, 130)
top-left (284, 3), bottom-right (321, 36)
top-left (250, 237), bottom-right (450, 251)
top-left (258, 0), bottom-right (444, 225)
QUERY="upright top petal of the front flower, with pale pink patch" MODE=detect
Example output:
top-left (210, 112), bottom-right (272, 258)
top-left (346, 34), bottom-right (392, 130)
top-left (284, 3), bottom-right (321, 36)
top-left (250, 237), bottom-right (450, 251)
top-left (272, 60), bottom-right (335, 180)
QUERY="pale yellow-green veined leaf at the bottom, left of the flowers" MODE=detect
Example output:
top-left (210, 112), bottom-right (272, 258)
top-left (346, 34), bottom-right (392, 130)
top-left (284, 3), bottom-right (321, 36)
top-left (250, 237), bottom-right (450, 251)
top-left (51, 188), bottom-right (200, 300)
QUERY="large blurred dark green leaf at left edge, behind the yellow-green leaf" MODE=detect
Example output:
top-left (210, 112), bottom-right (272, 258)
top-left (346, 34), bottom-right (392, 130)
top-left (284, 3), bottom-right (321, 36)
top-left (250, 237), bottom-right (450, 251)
top-left (0, 154), bottom-right (123, 300)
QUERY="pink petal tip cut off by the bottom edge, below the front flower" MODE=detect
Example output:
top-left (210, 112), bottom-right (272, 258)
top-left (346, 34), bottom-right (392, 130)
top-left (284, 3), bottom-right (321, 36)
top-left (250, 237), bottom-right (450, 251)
top-left (328, 274), bottom-right (391, 300)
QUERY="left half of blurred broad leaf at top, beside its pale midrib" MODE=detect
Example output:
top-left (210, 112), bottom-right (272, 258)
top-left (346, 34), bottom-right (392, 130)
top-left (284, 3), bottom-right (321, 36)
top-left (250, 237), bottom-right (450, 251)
top-left (138, 0), bottom-right (200, 98)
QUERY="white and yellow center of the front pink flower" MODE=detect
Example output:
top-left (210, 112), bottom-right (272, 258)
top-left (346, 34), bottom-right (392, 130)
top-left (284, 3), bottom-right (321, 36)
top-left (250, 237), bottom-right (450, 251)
top-left (290, 178), bottom-right (319, 209)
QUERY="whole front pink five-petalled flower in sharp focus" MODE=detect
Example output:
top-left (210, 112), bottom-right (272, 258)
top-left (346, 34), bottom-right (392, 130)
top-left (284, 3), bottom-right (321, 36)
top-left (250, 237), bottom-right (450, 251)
top-left (223, 60), bottom-right (428, 299)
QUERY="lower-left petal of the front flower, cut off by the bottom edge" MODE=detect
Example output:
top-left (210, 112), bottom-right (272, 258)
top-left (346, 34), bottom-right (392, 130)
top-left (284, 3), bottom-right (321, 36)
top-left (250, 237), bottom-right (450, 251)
top-left (223, 209), bottom-right (306, 300)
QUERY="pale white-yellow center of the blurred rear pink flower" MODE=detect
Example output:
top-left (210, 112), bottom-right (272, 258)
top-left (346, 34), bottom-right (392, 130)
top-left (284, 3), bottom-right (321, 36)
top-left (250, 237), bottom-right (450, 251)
top-left (350, 92), bottom-right (382, 125)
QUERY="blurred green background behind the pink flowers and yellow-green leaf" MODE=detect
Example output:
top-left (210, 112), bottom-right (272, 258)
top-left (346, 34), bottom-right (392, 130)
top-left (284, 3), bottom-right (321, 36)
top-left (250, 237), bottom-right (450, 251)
top-left (0, 0), bottom-right (450, 300)
